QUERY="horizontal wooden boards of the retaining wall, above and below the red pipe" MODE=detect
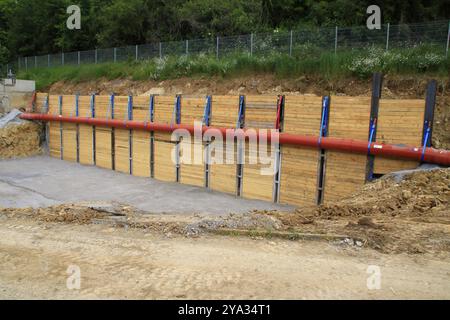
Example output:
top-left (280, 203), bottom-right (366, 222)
top-left (39, 82), bottom-right (436, 206)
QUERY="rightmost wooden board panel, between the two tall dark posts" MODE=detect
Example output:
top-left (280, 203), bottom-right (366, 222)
top-left (374, 99), bottom-right (425, 174)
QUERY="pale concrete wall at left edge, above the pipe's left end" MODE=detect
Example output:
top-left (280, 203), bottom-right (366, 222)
top-left (0, 79), bottom-right (36, 113)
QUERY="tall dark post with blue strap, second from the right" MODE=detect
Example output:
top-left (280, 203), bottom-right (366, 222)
top-left (366, 73), bottom-right (383, 182)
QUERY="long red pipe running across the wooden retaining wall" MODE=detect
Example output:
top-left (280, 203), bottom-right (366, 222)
top-left (20, 113), bottom-right (450, 166)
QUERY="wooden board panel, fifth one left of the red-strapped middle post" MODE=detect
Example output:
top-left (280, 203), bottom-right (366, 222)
top-left (132, 96), bottom-right (150, 177)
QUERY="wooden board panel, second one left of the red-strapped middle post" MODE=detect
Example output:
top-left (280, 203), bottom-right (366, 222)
top-left (209, 96), bottom-right (239, 194)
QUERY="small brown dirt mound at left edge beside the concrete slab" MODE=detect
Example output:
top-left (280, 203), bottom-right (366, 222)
top-left (0, 121), bottom-right (42, 159)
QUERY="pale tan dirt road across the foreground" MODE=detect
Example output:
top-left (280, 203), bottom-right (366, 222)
top-left (0, 216), bottom-right (450, 299)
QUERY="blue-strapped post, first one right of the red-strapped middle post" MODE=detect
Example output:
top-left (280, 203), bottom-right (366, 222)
top-left (316, 96), bottom-right (331, 205)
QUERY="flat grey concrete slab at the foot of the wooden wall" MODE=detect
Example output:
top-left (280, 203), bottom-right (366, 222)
top-left (0, 156), bottom-right (292, 214)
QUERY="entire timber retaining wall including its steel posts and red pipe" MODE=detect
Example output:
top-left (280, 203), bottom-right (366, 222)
top-left (15, 74), bottom-right (450, 206)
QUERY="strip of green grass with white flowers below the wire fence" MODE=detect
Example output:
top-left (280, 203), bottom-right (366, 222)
top-left (18, 46), bottom-right (450, 89)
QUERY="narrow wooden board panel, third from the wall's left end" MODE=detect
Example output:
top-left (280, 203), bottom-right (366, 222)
top-left (62, 95), bottom-right (77, 162)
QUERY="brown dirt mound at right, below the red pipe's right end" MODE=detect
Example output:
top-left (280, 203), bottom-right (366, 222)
top-left (316, 168), bottom-right (450, 217)
